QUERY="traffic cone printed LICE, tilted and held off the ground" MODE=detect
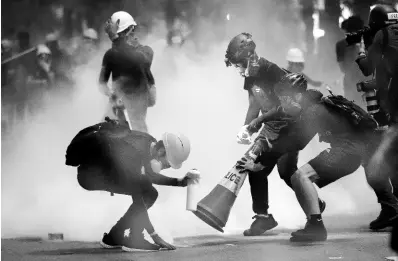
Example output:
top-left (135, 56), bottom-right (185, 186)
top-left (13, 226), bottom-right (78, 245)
top-left (193, 143), bottom-right (261, 233)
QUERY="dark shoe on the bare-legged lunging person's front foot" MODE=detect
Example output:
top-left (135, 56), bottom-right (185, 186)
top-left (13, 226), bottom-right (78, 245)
top-left (290, 220), bottom-right (327, 242)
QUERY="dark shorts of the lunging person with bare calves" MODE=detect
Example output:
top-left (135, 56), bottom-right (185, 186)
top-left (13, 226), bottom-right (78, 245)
top-left (308, 140), bottom-right (366, 188)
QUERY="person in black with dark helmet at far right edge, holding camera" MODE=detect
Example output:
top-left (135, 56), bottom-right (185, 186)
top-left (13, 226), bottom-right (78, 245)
top-left (357, 5), bottom-right (398, 251)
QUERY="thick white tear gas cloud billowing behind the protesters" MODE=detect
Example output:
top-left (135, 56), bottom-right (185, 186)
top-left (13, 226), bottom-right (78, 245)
top-left (1, 0), bottom-right (377, 240)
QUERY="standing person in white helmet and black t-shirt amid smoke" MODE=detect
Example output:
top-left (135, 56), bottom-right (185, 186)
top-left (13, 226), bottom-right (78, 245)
top-left (99, 11), bottom-right (156, 132)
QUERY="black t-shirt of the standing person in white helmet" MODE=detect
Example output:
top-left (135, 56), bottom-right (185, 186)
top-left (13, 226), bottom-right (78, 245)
top-left (100, 39), bottom-right (155, 92)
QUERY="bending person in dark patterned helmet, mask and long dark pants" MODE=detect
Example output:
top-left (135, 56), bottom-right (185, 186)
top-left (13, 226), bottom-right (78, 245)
top-left (225, 33), bottom-right (325, 236)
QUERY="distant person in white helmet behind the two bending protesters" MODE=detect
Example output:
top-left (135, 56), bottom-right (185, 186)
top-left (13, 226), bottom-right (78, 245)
top-left (286, 48), bottom-right (325, 87)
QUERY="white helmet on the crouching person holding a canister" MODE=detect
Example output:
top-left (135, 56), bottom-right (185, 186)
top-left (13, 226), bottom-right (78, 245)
top-left (162, 132), bottom-right (191, 169)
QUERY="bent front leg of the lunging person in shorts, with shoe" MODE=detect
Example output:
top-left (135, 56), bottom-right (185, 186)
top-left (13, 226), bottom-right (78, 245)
top-left (291, 143), bottom-right (361, 241)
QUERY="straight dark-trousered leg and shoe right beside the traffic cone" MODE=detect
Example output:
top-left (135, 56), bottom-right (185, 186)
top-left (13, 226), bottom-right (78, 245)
top-left (243, 153), bottom-right (278, 236)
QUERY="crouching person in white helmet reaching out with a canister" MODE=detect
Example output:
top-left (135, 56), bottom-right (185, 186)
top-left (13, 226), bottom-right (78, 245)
top-left (65, 118), bottom-right (196, 251)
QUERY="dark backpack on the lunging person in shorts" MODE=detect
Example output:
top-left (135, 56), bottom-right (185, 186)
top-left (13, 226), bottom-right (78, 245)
top-left (321, 93), bottom-right (378, 130)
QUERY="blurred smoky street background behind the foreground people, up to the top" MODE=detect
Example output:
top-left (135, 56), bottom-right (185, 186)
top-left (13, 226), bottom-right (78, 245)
top-left (1, 0), bottom-right (398, 240)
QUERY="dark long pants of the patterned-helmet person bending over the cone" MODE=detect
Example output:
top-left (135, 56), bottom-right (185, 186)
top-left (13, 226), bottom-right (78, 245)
top-left (249, 149), bottom-right (298, 214)
